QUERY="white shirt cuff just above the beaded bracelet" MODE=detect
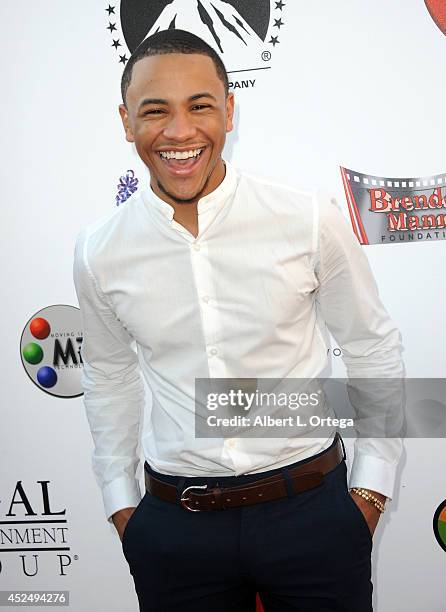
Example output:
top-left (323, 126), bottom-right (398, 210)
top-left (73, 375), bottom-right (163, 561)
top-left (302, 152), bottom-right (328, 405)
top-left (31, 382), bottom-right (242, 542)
top-left (349, 452), bottom-right (397, 499)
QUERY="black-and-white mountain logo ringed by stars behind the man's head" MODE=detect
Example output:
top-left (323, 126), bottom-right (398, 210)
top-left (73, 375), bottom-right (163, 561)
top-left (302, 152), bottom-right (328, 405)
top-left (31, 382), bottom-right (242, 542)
top-left (105, 0), bottom-right (287, 89)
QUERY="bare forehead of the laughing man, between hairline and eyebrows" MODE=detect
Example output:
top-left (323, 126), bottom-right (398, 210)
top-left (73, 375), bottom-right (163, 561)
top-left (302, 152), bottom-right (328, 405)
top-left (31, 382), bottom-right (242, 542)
top-left (127, 53), bottom-right (224, 101)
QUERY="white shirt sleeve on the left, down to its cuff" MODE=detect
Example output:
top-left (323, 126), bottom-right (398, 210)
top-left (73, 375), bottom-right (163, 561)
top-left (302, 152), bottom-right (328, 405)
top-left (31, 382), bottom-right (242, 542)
top-left (73, 230), bottom-right (144, 522)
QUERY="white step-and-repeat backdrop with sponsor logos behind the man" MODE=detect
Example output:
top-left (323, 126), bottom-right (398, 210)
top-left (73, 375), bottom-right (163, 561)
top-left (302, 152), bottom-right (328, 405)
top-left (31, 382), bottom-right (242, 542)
top-left (0, 0), bottom-right (446, 612)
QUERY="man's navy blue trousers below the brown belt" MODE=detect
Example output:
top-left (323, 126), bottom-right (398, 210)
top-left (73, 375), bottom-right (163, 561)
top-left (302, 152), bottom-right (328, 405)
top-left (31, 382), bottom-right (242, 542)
top-left (122, 442), bottom-right (372, 612)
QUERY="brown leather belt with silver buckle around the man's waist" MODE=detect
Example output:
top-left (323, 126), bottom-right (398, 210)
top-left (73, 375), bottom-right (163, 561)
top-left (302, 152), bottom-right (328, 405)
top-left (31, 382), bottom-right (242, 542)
top-left (144, 434), bottom-right (344, 512)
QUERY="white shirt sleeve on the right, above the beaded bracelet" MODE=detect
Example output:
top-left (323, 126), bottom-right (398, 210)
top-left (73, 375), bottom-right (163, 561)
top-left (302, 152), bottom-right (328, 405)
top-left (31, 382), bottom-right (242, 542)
top-left (315, 193), bottom-right (404, 498)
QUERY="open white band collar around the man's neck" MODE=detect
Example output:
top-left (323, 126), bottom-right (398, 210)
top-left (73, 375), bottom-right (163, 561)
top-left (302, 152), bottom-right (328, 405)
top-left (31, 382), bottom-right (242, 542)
top-left (145, 161), bottom-right (237, 222)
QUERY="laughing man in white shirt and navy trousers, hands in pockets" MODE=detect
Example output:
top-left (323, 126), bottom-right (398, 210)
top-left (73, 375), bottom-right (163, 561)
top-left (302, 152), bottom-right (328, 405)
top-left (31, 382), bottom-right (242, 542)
top-left (74, 29), bottom-right (403, 612)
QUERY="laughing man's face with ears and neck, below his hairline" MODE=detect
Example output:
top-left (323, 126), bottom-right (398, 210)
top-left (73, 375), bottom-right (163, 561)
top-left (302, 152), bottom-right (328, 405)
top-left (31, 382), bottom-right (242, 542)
top-left (119, 40), bottom-right (234, 236)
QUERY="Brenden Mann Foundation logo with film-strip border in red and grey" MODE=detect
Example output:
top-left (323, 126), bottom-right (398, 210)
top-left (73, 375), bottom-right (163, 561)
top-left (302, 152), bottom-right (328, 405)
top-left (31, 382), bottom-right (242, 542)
top-left (341, 167), bottom-right (446, 244)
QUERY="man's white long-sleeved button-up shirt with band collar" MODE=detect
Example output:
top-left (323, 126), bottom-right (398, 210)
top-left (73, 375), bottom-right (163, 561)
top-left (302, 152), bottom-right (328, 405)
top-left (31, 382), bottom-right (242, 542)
top-left (74, 163), bottom-right (403, 520)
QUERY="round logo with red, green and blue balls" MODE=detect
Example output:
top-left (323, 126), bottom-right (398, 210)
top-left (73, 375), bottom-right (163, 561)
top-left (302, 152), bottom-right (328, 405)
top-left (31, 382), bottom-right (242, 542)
top-left (20, 304), bottom-right (82, 397)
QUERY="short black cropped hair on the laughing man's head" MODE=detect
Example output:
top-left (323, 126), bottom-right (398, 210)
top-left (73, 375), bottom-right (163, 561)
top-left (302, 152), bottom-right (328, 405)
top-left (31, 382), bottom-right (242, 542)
top-left (121, 29), bottom-right (229, 105)
